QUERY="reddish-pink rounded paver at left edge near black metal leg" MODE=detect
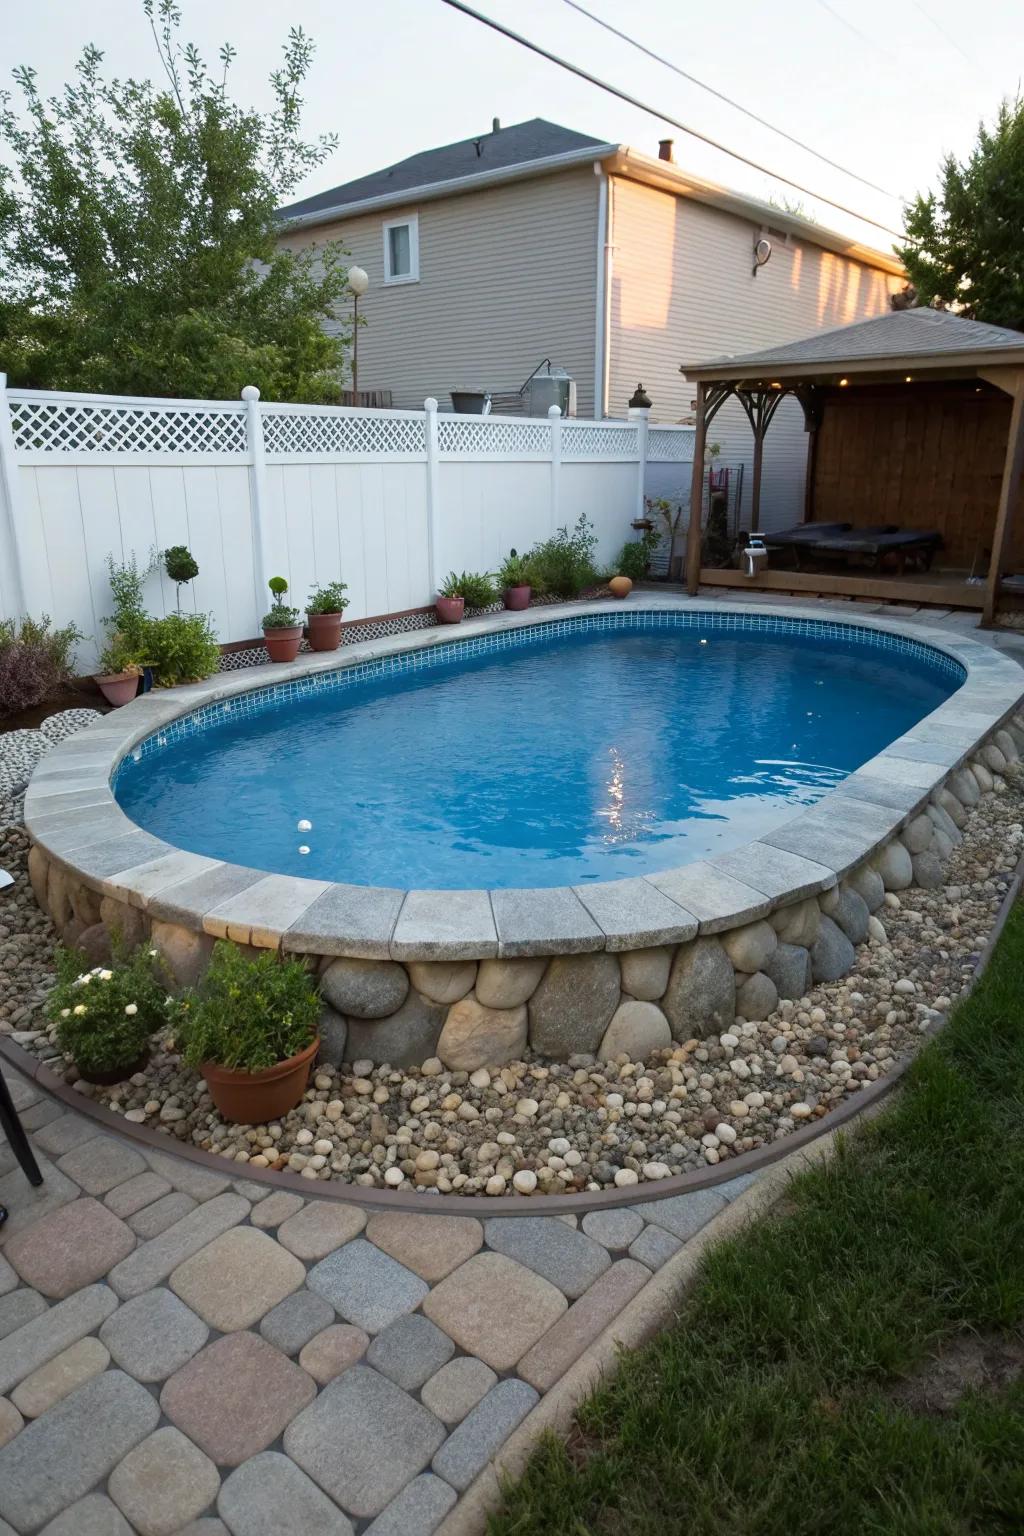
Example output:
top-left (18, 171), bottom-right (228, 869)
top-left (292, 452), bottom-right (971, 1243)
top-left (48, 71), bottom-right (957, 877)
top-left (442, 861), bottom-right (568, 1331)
top-left (5, 1195), bottom-right (135, 1301)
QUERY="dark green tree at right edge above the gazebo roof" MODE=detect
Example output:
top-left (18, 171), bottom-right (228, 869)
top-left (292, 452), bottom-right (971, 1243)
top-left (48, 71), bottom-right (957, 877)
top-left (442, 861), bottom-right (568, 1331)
top-left (898, 98), bottom-right (1024, 330)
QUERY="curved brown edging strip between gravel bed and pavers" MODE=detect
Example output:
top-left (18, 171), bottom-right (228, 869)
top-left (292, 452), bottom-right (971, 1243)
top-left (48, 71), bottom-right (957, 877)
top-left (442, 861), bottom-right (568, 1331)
top-left (0, 857), bottom-right (1024, 1220)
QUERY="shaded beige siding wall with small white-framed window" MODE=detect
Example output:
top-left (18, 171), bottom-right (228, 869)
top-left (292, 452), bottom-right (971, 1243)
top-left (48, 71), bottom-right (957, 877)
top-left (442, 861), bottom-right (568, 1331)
top-left (280, 164), bottom-right (599, 416)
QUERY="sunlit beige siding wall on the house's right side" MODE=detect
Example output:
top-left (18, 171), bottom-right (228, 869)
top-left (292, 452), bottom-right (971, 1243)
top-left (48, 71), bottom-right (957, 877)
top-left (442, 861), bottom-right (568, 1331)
top-left (608, 177), bottom-right (901, 528)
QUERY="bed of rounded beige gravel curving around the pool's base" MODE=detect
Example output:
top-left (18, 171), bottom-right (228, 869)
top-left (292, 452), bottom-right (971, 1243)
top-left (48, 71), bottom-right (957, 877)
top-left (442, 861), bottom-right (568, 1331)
top-left (0, 711), bottom-right (1024, 1195)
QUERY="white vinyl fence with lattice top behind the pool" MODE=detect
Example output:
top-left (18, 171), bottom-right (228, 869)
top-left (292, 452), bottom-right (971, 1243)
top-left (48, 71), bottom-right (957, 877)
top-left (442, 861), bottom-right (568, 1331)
top-left (0, 375), bottom-right (694, 668)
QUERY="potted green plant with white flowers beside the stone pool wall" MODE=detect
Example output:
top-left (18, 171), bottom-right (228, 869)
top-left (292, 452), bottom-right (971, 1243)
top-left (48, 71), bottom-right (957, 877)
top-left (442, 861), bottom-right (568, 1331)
top-left (46, 945), bottom-right (173, 1084)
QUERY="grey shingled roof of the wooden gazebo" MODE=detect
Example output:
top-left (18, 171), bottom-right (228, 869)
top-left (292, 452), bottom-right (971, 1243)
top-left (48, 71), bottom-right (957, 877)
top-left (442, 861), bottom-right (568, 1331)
top-left (683, 307), bottom-right (1024, 373)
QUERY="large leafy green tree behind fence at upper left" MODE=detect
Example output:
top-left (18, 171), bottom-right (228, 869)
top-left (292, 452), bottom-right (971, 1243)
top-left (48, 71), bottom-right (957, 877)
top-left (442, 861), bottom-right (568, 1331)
top-left (0, 0), bottom-right (348, 401)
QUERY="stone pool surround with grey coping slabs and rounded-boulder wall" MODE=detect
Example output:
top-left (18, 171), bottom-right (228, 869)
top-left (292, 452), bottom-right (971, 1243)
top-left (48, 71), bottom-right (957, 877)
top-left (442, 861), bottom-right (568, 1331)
top-left (25, 594), bottom-right (1024, 1071)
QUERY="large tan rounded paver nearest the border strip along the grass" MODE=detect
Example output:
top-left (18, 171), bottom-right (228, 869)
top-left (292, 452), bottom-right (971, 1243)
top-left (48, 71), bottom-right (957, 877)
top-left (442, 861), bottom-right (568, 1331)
top-left (424, 1253), bottom-right (570, 1372)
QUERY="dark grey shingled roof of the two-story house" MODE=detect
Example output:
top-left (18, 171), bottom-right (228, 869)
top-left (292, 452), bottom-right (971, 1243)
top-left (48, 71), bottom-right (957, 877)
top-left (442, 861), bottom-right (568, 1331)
top-left (278, 117), bottom-right (608, 220)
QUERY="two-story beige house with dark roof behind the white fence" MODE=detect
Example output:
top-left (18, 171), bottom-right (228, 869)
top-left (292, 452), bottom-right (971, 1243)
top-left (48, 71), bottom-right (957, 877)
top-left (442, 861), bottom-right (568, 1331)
top-left (281, 118), bottom-right (903, 527)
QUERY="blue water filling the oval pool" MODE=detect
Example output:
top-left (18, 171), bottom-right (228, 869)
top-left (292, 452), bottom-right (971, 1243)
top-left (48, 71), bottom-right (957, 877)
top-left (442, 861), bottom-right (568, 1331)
top-left (115, 614), bottom-right (963, 889)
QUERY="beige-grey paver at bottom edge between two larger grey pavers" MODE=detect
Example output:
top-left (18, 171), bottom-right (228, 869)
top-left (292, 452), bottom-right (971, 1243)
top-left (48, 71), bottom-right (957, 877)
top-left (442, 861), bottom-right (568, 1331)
top-left (107, 1424), bottom-right (221, 1536)
